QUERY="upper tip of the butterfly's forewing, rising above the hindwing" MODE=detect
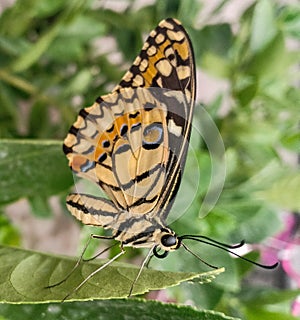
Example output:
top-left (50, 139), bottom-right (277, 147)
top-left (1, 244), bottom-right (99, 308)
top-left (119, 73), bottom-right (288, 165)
top-left (114, 18), bottom-right (195, 97)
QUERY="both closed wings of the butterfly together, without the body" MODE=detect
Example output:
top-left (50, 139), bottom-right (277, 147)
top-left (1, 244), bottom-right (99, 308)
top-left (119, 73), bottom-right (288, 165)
top-left (64, 19), bottom-right (195, 225)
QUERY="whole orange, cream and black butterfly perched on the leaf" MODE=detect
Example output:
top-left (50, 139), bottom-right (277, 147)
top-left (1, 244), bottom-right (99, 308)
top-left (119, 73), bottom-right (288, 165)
top-left (59, 18), bottom-right (278, 298)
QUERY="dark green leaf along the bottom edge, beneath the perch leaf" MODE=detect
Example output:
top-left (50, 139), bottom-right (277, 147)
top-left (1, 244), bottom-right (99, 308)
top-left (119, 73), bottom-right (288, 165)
top-left (0, 299), bottom-right (238, 320)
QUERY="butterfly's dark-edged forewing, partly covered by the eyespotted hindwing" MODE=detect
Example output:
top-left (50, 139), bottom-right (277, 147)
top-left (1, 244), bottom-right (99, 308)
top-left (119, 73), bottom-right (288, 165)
top-left (115, 18), bottom-right (196, 218)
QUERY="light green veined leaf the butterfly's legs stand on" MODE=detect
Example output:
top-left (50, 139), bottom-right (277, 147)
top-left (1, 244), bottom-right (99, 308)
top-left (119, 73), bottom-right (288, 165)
top-left (0, 247), bottom-right (224, 303)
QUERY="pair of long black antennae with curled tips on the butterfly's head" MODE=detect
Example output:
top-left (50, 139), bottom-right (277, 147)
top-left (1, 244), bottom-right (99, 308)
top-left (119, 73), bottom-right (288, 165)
top-left (178, 235), bottom-right (279, 269)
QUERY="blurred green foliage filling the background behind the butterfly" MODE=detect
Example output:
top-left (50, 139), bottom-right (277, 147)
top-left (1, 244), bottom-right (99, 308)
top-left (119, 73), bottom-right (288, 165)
top-left (0, 0), bottom-right (300, 320)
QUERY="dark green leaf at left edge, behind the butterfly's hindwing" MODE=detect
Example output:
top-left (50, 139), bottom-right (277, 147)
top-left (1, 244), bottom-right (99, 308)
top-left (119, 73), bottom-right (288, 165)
top-left (0, 140), bottom-right (73, 203)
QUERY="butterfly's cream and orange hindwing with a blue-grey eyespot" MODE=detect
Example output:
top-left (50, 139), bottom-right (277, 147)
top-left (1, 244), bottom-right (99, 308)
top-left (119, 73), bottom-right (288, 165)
top-left (64, 88), bottom-right (169, 214)
